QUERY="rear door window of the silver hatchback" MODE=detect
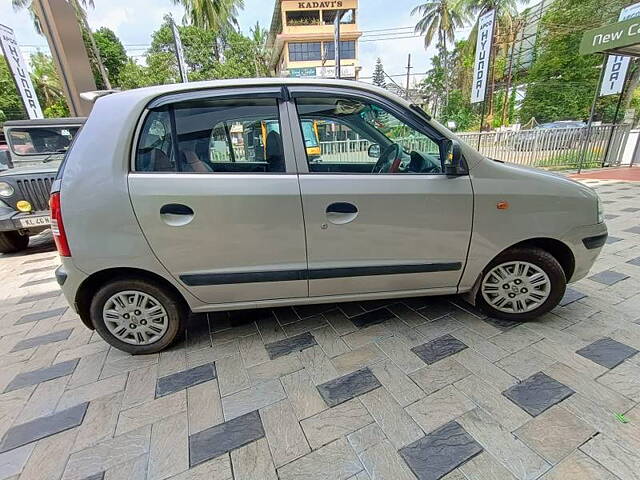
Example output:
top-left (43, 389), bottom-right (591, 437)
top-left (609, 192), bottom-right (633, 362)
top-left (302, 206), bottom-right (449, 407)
top-left (136, 97), bottom-right (285, 173)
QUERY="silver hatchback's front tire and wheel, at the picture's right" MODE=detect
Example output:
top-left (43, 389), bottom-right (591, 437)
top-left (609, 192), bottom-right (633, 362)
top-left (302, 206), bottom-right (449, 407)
top-left (476, 247), bottom-right (567, 322)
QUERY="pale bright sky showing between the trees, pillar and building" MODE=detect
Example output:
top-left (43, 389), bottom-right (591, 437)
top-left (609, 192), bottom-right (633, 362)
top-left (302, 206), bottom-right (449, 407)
top-left (0, 0), bottom-right (476, 86)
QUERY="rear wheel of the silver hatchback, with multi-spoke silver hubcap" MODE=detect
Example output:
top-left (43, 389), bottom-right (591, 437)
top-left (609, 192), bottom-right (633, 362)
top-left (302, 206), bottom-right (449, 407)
top-left (90, 280), bottom-right (185, 355)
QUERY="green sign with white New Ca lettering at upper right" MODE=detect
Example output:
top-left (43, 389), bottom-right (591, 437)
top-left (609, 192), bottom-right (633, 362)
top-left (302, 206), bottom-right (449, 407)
top-left (580, 18), bottom-right (640, 55)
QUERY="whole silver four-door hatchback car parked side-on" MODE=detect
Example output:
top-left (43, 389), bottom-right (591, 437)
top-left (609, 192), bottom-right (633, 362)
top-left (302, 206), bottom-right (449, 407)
top-left (51, 78), bottom-right (607, 354)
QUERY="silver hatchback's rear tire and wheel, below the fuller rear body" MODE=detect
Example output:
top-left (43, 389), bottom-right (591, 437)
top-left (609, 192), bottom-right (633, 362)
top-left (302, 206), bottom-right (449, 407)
top-left (89, 279), bottom-right (187, 355)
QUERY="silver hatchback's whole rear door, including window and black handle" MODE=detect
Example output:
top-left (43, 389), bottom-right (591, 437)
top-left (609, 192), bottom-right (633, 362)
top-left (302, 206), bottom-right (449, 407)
top-left (129, 88), bottom-right (308, 303)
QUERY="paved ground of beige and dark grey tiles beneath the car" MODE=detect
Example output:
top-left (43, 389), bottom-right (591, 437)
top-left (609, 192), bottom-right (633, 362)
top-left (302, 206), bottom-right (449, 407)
top-left (0, 179), bottom-right (640, 480)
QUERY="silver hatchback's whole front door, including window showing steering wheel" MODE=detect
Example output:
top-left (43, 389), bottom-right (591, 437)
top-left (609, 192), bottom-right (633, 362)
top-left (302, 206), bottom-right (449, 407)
top-left (292, 89), bottom-right (473, 296)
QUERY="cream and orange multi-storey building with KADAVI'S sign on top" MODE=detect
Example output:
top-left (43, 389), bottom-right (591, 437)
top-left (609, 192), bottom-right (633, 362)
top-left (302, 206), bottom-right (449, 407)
top-left (268, 0), bottom-right (362, 80)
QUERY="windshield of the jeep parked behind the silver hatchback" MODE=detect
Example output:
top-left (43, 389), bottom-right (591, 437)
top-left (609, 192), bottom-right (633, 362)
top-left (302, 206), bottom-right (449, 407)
top-left (7, 126), bottom-right (80, 156)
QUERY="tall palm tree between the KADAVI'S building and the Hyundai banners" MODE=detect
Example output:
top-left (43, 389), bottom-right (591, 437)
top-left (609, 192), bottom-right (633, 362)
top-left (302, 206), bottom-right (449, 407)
top-left (411, 0), bottom-right (466, 107)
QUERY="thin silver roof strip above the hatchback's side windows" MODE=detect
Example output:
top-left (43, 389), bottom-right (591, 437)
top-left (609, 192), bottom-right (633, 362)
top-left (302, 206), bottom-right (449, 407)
top-left (96, 77), bottom-right (410, 106)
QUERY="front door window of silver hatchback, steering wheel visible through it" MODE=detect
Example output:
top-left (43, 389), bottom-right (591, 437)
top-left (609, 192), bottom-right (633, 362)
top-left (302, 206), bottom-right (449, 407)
top-left (296, 97), bottom-right (443, 174)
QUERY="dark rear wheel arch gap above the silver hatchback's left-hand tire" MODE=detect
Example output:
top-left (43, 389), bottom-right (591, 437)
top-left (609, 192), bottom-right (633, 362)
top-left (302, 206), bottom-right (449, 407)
top-left (74, 267), bottom-right (189, 330)
